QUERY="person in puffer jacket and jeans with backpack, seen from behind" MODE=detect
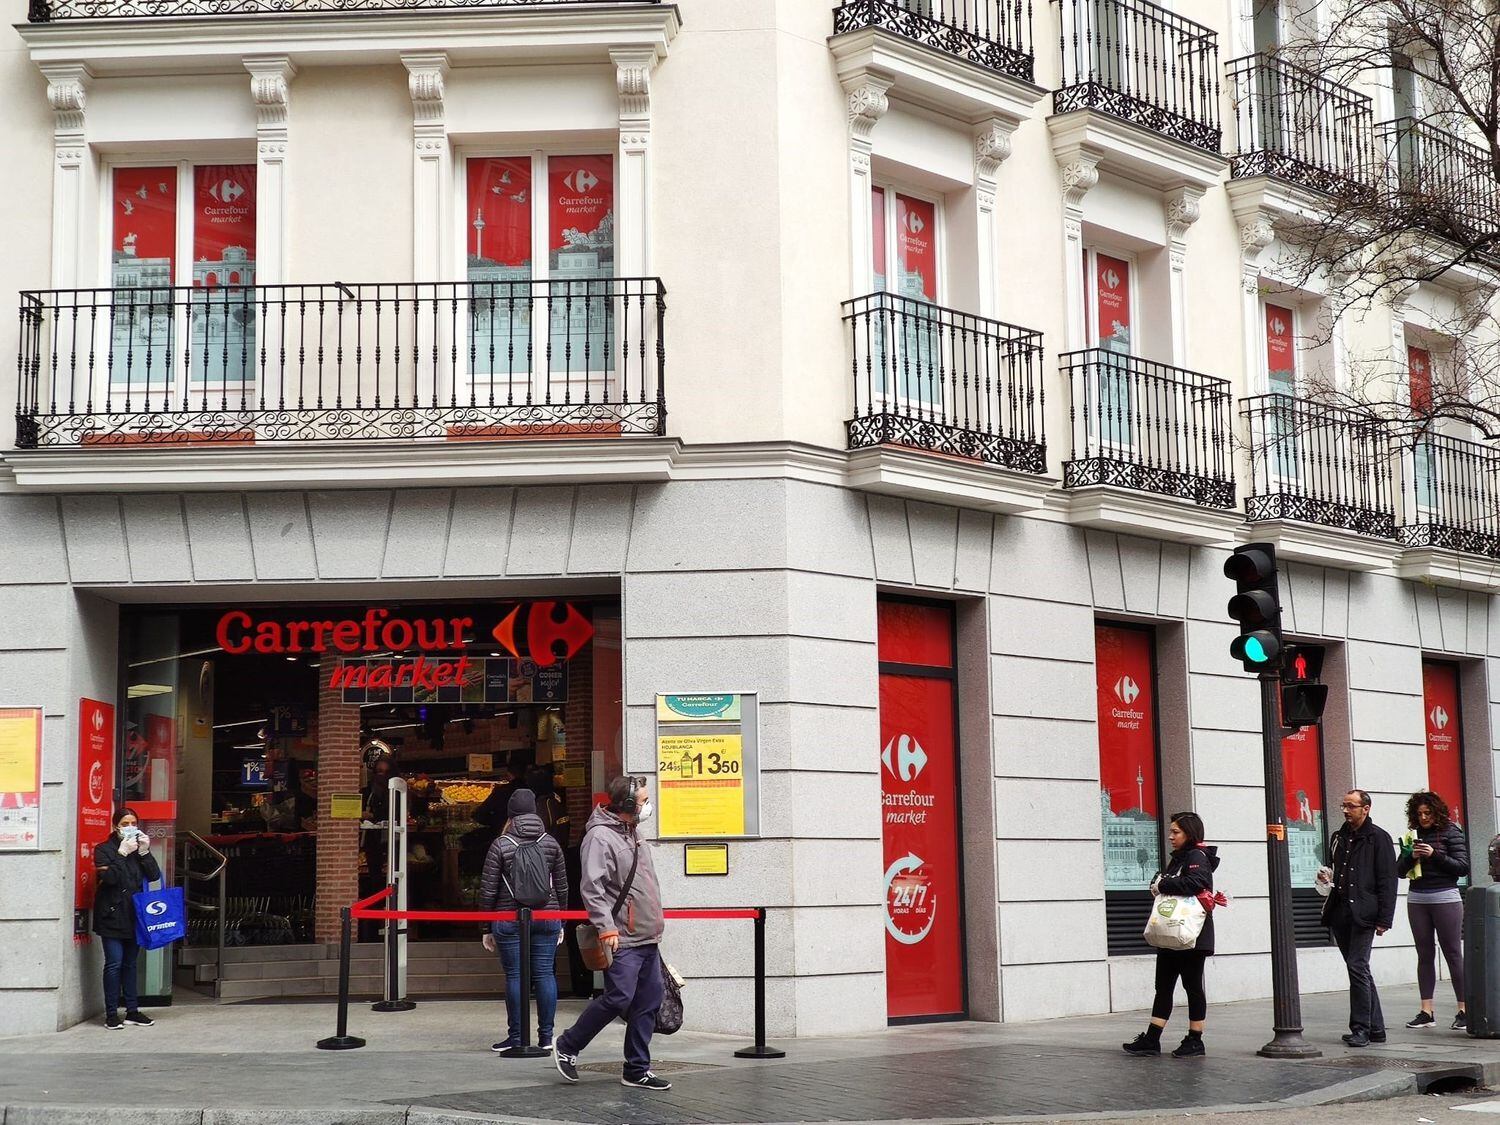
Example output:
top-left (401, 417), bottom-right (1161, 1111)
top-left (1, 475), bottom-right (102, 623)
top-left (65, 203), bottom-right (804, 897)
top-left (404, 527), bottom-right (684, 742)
top-left (479, 789), bottom-right (567, 1053)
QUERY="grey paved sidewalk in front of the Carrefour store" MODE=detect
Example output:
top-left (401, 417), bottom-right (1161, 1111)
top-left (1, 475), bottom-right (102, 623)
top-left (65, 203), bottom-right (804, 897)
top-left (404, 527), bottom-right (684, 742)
top-left (0, 987), bottom-right (1500, 1125)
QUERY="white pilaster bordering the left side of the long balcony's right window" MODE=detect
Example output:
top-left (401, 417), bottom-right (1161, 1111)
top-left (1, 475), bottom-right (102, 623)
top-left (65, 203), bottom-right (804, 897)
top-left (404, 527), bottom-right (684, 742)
top-left (401, 53), bottom-right (453, 282)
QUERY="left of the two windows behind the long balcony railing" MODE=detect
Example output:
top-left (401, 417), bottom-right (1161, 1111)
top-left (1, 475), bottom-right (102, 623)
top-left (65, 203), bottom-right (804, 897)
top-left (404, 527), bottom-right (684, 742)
top-left (108, 162), bottom-right (257, 393)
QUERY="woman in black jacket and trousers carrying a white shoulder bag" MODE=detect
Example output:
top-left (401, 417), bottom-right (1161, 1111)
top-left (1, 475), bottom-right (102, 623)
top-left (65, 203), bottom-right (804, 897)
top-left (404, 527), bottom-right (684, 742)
top-left (1124, 813), bottom-right (1218, 1059)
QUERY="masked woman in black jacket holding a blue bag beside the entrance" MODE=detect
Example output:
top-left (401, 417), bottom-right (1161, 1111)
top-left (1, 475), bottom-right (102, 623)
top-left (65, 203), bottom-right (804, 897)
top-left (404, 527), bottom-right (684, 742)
top-left (93, 809), bottom-right (162, 1031)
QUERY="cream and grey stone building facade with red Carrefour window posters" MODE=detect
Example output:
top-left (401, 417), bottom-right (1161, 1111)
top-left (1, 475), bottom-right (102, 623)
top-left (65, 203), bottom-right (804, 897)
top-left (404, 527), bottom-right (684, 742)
top-left (0, 0), bottom-right (1500, 1035)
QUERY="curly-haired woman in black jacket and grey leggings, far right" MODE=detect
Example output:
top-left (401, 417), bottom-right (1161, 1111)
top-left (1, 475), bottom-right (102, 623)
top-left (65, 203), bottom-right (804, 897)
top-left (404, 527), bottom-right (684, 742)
top-left (1397, 792), bottom-right (1469, 1031)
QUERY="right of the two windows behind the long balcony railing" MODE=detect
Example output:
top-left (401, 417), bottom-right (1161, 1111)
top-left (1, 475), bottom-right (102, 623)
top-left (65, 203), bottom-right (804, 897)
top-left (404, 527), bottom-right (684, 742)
top-left (464, 153), bottom-right (620, 402)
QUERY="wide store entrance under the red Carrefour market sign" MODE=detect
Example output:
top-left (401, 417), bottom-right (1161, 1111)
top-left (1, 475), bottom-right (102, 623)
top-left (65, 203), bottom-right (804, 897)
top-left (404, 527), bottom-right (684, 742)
top-left (119, 600), bottom-right (621, 1001)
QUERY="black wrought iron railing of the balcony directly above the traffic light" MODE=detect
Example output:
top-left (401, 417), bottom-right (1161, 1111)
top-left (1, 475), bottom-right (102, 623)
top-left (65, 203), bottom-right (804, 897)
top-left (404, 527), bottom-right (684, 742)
top-left (1241, 395), bottom-right (1397, 539)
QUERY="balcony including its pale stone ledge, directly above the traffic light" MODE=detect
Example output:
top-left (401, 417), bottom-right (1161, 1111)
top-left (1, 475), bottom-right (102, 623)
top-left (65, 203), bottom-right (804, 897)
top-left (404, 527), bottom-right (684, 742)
top-left (1241, 395), bottom-right (1397, 570)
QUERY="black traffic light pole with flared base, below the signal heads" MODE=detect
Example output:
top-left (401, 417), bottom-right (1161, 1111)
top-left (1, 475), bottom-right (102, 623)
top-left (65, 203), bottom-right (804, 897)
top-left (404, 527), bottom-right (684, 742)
top-left (1256, 672), bottom-right (1323, 1059)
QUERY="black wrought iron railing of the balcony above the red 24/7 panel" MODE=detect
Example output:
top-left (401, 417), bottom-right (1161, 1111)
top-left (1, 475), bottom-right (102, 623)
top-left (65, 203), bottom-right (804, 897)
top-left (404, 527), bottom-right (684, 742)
top-left (843, 293), bottom-right (1047, 474)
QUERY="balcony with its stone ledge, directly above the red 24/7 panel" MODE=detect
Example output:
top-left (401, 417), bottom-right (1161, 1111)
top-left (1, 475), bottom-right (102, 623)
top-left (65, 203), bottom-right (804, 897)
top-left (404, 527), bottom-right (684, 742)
top-left (843, 293), bottom-right (1055, 512)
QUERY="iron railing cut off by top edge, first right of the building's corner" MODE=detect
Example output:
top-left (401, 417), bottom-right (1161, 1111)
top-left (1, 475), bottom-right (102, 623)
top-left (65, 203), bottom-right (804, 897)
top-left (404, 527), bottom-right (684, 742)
top-left (834, 0), bottom-right (1034, 83)
